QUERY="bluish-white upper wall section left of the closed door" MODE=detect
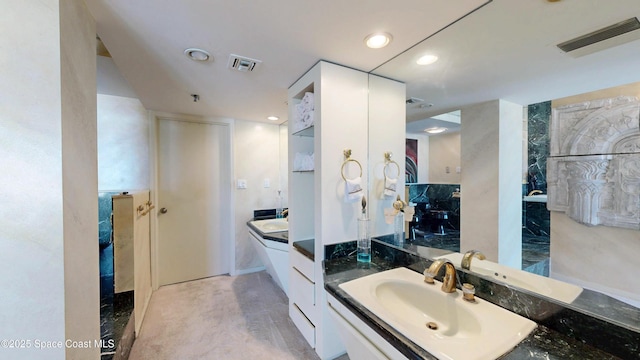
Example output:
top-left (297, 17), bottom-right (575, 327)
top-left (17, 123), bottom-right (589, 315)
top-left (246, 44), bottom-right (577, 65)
top-left (98, 94), bottom-right (150, 191)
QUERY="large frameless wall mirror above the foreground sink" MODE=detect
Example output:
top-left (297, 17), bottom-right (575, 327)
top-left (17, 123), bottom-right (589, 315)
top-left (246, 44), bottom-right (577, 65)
top-left (373, 1), bottom-right (640, 331)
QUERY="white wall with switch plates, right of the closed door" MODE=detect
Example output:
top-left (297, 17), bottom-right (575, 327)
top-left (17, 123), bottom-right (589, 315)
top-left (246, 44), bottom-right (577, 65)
top-left (233, 120), bottom-right (287, 273)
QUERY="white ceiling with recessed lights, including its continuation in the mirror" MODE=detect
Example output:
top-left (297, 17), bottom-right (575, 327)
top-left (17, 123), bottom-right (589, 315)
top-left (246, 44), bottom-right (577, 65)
top-left (85, 0), bottom-right (640, 126)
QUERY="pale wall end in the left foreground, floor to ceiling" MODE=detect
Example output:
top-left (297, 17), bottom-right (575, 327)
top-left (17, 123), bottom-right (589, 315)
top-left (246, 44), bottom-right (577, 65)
top-left (0, 0), bottom-right (100, 359)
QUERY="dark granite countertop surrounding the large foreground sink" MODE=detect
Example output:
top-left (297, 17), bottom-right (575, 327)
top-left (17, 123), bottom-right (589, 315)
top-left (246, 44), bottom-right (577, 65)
top-left (324, 241), bottom-right (624, 360)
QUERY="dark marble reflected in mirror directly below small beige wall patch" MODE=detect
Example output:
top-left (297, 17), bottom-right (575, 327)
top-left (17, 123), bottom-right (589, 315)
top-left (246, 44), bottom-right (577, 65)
top-left (407, 184), bottom-right (460, 230)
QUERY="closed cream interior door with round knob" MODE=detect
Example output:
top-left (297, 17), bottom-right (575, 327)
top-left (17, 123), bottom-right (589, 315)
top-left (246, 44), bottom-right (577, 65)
top-left (157, 119), bottom-right (232, 285)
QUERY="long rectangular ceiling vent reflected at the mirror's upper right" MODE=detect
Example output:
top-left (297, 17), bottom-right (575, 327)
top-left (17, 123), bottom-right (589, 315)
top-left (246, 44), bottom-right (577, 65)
top-left (557, 17), bottom-right (640, 56)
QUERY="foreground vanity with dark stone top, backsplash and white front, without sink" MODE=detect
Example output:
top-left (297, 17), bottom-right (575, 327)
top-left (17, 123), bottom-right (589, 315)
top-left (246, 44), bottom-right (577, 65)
top-left (324, 240), bottom-right (640, 360)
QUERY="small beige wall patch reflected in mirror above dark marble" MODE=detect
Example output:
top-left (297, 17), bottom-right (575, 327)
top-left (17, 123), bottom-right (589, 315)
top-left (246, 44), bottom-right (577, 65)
top-left (429, 132), bottom-right (460, 184)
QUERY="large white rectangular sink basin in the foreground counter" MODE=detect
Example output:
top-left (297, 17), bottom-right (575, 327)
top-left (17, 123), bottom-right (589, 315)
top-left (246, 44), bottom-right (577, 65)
top-left (340, 268), bottom-right (536, 360)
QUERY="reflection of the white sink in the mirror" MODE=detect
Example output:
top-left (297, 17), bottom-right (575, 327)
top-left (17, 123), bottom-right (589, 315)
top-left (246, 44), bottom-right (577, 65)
top-left (440, 253), bottom-right (582, 303)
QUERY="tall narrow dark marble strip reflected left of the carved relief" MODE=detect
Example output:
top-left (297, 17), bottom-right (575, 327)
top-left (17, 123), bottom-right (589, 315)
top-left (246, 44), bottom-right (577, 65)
top-left (527, 101), bottom-right (551, 194)
